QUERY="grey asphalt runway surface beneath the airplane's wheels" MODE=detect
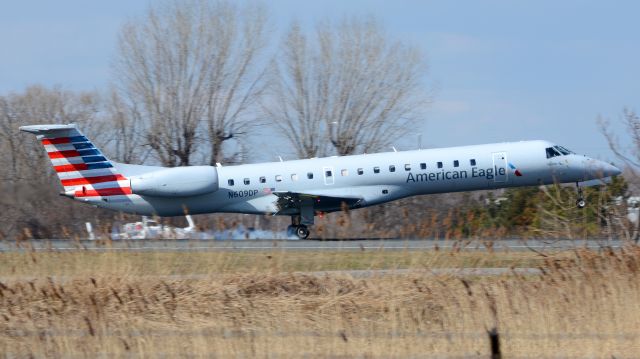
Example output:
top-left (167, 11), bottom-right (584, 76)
top-left (0, 239), bottom-right (625, 252)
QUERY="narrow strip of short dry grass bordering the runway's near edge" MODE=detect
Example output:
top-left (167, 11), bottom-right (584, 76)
top-left (0, 247), bottom-right (544, 280)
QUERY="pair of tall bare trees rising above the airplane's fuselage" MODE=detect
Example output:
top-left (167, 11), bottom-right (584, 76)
top-left (109, 0), bottom-right (428, 166)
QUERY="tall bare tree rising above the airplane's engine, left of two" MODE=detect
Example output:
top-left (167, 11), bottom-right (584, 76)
top-left (114, 0), bottom-right (265, 166)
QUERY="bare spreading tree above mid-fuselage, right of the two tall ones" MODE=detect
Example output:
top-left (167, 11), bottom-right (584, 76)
top-left (263, 19), bottom-right (428, 157)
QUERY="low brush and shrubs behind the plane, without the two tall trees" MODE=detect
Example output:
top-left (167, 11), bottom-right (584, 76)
top-left (0, 86), bottom-right (640, 240)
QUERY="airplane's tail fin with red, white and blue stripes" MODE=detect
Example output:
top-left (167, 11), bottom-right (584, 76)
top-left (20, 124), bottom-right (131, 198)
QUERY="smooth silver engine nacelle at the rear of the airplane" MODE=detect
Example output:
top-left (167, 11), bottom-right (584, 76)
top-left (130, 166), bottom-right (218, 197)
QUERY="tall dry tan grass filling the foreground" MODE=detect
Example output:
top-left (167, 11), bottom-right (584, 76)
top-left (0, 247), bottom-right (640, 358)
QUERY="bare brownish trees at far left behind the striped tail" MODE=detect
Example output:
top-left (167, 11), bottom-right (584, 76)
top-left (0, 86), bottom-right (109, 237)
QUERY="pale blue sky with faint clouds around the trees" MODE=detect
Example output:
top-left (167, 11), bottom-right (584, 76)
top-left (0, 0), bottom-right (640, 161)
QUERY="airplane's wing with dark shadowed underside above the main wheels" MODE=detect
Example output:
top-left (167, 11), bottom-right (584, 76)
top-left (272, 191), bottom-right (363, 214)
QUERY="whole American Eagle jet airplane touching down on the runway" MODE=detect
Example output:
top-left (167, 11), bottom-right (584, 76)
top-left (20, 124), bottom-right (621, 239)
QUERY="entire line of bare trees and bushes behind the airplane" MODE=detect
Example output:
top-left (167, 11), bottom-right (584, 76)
top-left (0, 0), bottom-right (640, 242)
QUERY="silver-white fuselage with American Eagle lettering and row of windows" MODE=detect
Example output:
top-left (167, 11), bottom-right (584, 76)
top-left (89, 141), bottom-right (620, 216)
